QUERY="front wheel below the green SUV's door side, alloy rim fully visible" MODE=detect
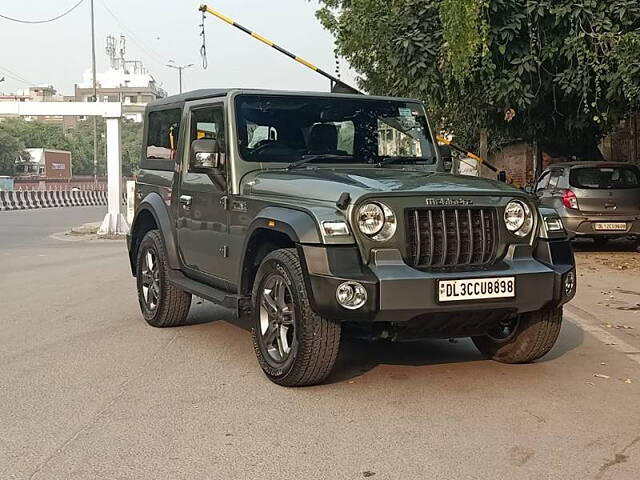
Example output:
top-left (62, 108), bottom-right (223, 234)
top-left (251, 249), bottom-right (341, 387)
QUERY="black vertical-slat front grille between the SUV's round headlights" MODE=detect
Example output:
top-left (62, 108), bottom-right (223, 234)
top-left (406, 208), bottom-right (497, 268)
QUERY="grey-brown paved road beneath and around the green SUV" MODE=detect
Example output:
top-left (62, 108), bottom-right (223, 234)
top-left (0, 208), bottom-right (640, 480)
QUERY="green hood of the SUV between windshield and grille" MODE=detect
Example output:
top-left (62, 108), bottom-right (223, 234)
top-left (241, 168), bottom-right (522, 202)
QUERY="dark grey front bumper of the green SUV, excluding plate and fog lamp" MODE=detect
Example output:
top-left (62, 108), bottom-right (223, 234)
top-left (301, 239), bottom-right (575, 323)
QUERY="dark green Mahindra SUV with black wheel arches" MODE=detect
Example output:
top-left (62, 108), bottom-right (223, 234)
top-left (128, 90), bottom-right (576, 386)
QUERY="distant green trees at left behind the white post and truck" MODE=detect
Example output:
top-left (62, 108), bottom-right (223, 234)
top-left (0, 118), bottom-right (142, 176)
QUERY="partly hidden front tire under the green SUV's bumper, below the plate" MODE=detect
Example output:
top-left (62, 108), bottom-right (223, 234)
top-left (472, 308), bottom-right (562, 363)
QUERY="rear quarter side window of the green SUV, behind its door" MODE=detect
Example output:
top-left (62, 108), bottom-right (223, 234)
top-left (147, 108), bottom-right (182, 161)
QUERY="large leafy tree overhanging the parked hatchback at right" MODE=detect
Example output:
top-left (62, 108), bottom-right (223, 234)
top-left (317, 0), bottom-right (640, 157)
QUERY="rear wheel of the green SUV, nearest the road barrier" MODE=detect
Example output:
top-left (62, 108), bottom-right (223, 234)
top-left (136, 230), bottom-right (191, 328)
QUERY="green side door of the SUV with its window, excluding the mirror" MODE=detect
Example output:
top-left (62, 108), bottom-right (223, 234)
top-left (177, 102), bottom-right (231, 287)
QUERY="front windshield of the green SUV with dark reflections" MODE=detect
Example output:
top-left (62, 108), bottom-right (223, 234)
top-left (236, 95), bottom-right (435, 164)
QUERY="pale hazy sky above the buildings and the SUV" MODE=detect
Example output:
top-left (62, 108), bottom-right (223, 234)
top-left (0, 0), bottom-right (355, 95)
